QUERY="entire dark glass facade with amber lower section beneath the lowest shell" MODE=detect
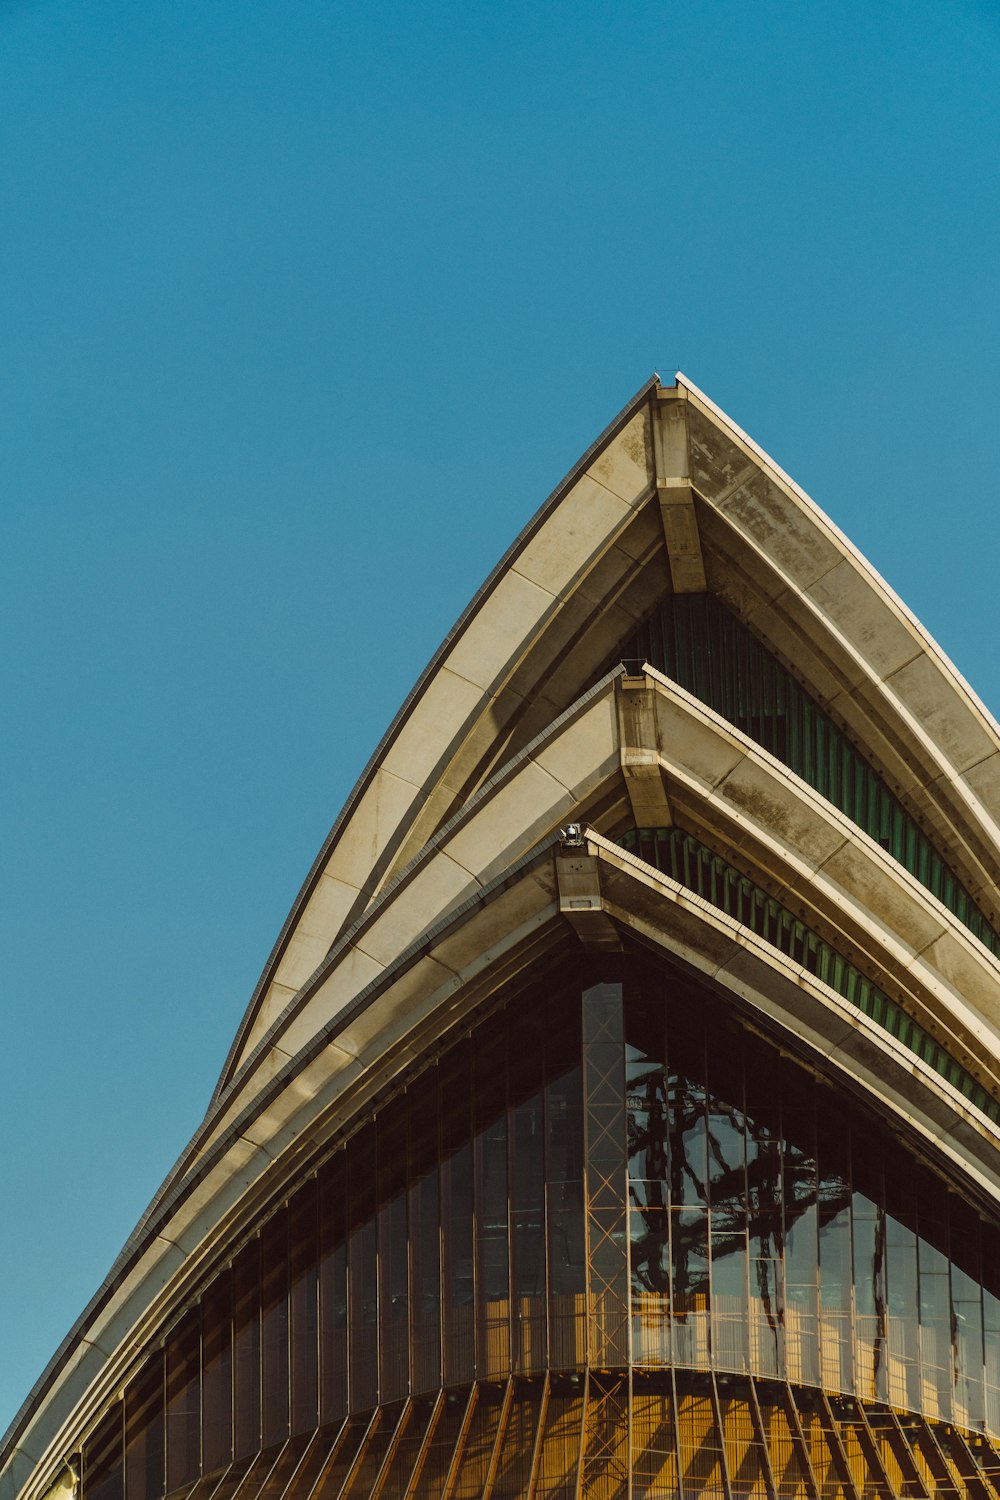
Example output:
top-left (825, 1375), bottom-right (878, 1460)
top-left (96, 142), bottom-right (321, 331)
top-left (81, 954), bottom-right (1000, 1500)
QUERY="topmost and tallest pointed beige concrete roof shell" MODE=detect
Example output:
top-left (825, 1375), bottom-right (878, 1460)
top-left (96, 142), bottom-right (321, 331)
top-left (219, 375), bottom-right (1000, 1091)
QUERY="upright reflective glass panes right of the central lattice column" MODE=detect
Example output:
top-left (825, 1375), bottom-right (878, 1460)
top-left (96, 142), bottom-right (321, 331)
top-left (624, 974), bottom-right (1000, 1436)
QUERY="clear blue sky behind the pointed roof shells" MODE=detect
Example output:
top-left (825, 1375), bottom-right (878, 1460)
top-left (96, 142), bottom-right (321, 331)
top-left (0, 0), bottom-right (1000, 1428)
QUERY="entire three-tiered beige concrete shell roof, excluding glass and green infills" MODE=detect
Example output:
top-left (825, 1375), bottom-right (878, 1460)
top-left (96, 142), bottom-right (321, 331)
top-left (0, 375), bottom-right (1000, 1500)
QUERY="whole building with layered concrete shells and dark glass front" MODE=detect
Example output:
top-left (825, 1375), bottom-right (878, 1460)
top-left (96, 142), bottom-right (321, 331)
top-left (0, 377), bottom-right (1000, 1500)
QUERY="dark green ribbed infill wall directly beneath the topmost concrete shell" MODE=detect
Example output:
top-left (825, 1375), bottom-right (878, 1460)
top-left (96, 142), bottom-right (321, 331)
top-left (624, 594), bottom-right (1000, 956)
